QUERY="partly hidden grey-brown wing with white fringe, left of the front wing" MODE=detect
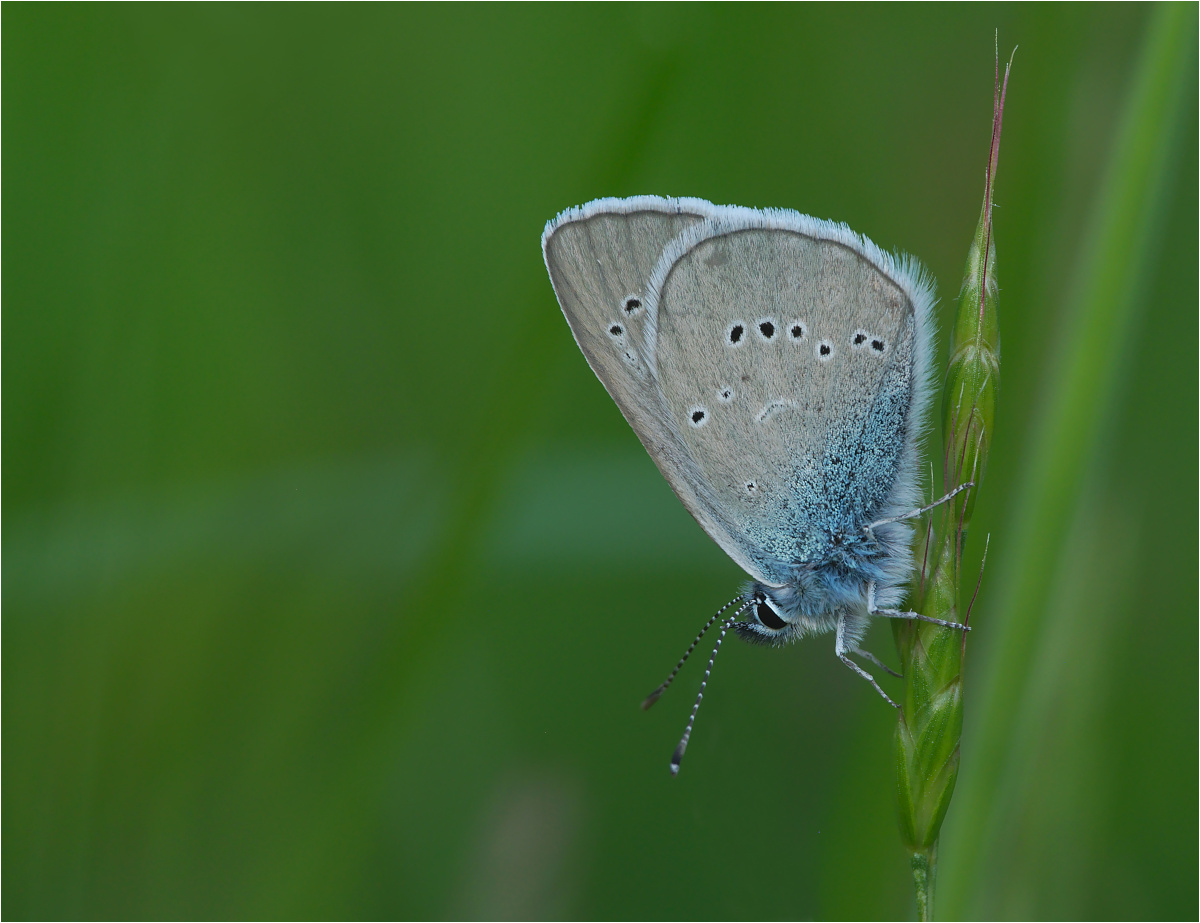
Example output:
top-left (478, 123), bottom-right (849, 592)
top-left (542, 196), bottom-right (766, 580)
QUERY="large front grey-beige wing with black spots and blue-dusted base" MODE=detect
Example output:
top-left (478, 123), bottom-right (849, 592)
top-left (647, 208), bottom-right (934, 585)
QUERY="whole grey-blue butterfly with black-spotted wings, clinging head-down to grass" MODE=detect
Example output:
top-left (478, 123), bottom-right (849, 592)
top-left (542, 196), bottom-right (970, 773)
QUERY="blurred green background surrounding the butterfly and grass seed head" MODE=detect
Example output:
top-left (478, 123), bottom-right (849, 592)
top-left (2, 5), bottom-right (1198, 918)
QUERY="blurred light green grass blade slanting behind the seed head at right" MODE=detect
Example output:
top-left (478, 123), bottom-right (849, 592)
top-left (941, 5), bottom-right (1195, 917)
